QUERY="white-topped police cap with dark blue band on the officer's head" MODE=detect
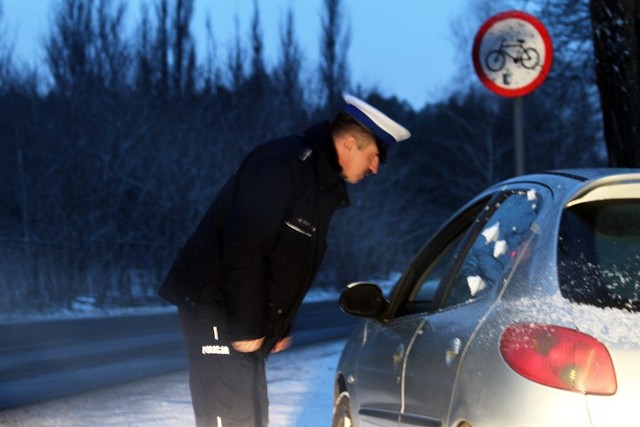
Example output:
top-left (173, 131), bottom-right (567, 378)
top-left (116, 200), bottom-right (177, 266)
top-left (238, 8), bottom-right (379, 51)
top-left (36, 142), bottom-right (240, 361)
top-left (342, 94), bottom-right (411, 149)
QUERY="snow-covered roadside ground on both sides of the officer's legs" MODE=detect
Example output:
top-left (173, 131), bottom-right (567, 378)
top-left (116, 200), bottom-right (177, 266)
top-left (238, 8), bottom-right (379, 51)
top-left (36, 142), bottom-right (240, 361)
top-left (0, 340), bottom-right (344, 427)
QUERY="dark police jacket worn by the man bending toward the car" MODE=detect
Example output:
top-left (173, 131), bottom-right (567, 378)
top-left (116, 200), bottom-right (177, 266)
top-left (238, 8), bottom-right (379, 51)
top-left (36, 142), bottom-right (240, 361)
top-left (159, 122), bottom-right (349, 351)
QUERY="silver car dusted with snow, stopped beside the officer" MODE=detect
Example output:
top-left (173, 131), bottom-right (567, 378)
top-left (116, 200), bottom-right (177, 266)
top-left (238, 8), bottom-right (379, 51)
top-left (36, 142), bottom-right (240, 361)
top-left (333, 169), bottom-right (640, 427)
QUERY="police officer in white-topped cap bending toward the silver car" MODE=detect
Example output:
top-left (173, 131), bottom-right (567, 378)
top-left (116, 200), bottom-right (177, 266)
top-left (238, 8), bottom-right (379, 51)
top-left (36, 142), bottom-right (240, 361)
top-left (159, 95), bottom-right (410, 427)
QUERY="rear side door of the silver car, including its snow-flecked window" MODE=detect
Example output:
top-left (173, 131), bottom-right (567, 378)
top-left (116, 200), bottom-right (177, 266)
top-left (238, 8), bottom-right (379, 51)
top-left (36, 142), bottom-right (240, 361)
top-left (400, 191), bottom-right (540, 426)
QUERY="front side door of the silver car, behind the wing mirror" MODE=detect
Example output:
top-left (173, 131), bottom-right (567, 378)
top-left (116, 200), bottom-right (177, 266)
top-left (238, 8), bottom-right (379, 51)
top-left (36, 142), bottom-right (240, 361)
top-left (353, 196), bottom-right (490, 426)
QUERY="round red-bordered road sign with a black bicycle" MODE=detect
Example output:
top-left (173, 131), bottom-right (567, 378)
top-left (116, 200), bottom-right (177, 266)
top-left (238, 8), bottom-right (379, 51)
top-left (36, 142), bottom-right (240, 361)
top-left (472, 11), bottom-right (553, 97)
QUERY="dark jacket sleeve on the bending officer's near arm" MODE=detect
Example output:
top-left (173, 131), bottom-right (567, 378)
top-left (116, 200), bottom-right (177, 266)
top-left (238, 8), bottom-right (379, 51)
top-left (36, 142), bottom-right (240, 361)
top-left (223, 150), bottom-right (295, 341)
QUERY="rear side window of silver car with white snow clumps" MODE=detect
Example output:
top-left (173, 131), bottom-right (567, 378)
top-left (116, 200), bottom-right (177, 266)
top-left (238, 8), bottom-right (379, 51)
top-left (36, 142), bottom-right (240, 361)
top-left (442, 190), bottom-right (540, 307)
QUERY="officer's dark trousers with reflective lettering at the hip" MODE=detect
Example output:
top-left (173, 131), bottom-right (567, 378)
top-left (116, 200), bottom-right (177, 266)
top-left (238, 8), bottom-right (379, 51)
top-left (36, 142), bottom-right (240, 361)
top-left (178, 309), bottom-right (269, 427)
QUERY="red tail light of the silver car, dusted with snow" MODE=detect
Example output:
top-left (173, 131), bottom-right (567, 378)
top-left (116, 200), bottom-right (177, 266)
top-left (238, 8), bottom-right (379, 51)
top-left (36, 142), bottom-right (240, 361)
top-left (500, 324), bottom-right (618, 395)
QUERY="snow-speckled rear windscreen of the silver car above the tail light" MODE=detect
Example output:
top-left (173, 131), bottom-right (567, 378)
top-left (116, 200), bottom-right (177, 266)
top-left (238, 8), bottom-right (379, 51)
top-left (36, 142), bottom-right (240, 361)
top-left (558, 200), bottom-right (640, 311)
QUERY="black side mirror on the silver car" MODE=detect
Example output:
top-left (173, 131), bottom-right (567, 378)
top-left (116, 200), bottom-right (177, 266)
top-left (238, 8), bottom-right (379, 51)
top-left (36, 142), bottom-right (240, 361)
top-left (340, 282), bottom-right (389, 318)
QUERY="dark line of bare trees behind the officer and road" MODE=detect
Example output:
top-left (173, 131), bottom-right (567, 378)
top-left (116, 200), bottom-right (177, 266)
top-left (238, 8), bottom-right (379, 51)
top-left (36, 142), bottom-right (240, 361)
top-left (0, 0), bottom-right (606, 312)
